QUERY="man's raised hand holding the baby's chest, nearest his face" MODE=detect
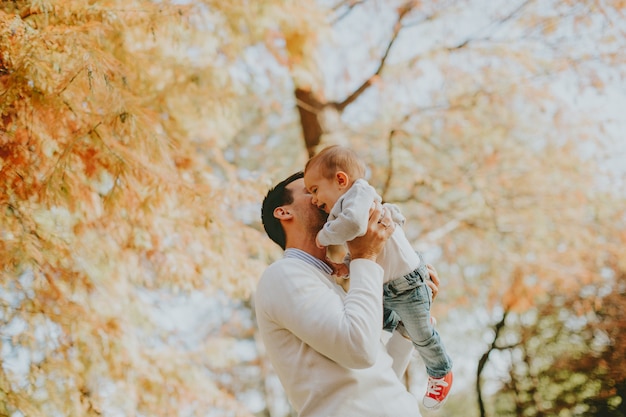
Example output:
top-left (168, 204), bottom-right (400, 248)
top-left (347, 203), bottom-right (394, 261)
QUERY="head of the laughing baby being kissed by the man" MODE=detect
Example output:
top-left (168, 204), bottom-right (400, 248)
top-left (304, 145), bottom-right (366, 213)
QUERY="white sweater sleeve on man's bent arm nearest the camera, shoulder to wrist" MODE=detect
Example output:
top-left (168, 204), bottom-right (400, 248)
top-left (256, 259), bottom-right (383, 368)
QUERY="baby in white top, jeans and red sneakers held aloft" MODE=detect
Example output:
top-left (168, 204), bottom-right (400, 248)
top-left (304, 145), bottom-right (452, 410)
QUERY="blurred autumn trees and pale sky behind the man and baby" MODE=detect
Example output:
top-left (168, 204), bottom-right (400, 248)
top-left (0, 0), bottom-right (626, 417)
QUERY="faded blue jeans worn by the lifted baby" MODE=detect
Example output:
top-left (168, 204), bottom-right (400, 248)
top-left (383, 254), bottom-right (452, 378)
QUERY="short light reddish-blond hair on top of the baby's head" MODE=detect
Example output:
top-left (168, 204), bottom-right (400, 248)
top-left (304, 145), bottom-right (366, 182)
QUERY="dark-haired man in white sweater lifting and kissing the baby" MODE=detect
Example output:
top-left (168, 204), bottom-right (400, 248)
top-left (255, 173), bottom-right (438, 417)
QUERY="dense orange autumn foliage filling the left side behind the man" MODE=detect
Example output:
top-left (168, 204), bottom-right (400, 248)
top-left (0, 0), bottom-right (304, 416)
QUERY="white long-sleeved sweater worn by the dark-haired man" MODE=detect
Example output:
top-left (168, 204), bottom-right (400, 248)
top-left (255, 258), bottom-right (421, 417)
